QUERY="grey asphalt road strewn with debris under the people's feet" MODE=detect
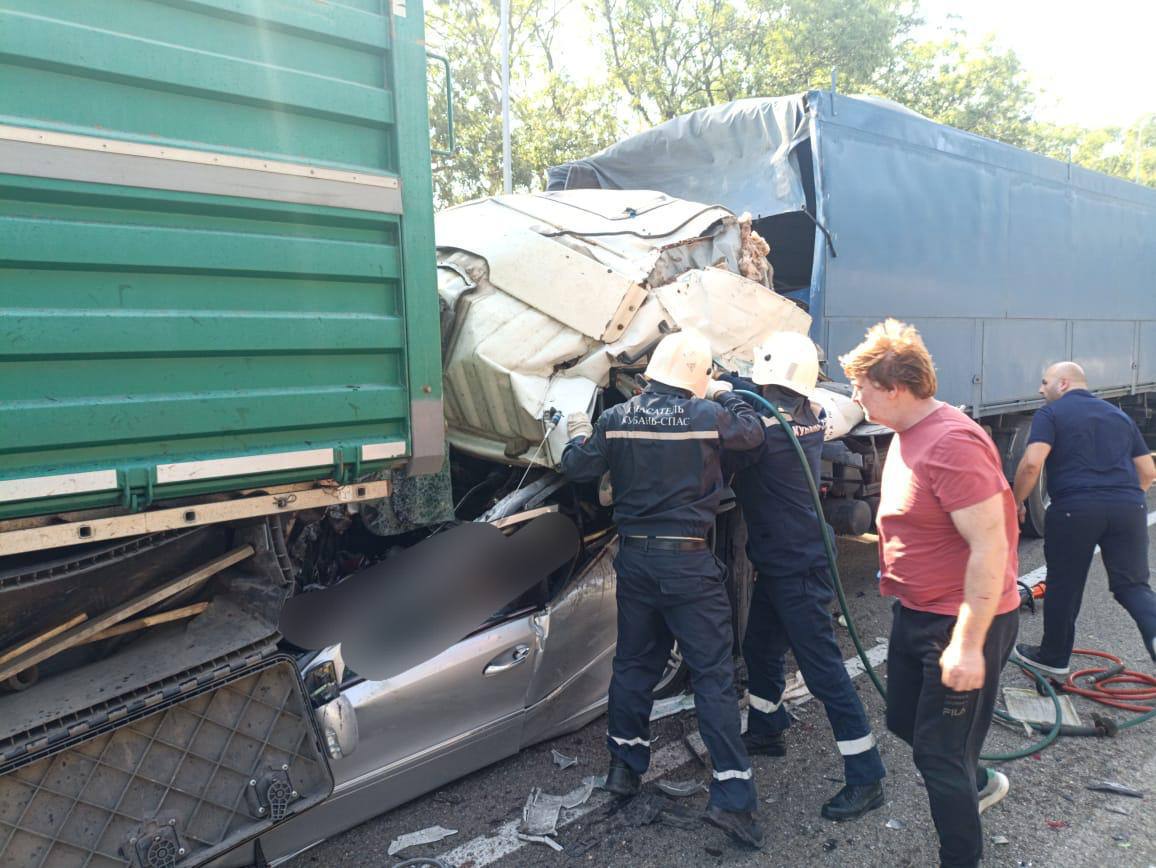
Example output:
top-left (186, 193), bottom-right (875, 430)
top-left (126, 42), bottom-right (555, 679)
top-left (290, 497), bottom-right (1156, 868)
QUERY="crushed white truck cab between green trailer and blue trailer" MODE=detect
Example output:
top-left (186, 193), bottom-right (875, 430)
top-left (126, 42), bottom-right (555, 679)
top-left (437, 191), bottom-right (810, 467)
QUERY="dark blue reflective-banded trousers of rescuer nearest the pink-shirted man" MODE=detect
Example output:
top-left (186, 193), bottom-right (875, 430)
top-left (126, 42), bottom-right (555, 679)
top-left (742, 570), bottom-right (887, 785)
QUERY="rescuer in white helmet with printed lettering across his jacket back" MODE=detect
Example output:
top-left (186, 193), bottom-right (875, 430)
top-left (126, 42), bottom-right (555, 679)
top-left (562, 332), bottom-right (763, 847)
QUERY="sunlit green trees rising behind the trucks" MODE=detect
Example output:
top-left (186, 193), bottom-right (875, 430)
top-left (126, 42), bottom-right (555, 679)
top-left (427, 0), bottom-right (1156, 196)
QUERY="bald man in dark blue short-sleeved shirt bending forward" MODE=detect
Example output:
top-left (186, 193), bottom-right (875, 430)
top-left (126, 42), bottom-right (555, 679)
top-left (1012, 362), bottom-right (1156, 677)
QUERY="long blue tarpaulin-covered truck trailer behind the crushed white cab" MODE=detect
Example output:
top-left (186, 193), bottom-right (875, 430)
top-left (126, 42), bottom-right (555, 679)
top-left (549, 91), bottom-right (1156, 534)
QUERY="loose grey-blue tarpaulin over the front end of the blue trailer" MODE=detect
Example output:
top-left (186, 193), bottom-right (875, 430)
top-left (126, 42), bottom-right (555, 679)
top-left (547, 94), bottom-right (809, 218)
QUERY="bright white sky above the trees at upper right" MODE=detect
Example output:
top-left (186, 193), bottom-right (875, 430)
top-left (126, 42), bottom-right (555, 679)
top-left (921, 0), bottom-right (1156, 126)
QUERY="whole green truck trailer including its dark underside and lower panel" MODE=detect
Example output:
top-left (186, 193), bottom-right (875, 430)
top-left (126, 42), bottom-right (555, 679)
top-left (0, 0), bottom-right (444, 866)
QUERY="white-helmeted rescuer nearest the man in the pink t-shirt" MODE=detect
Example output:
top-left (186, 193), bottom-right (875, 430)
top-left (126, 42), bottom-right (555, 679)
top-left (724, 332), bottom-right (885, 819)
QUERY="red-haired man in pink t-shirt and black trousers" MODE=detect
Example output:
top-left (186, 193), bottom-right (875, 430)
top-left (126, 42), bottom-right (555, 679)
top-left (839, 319), bottom-right (1020, 868)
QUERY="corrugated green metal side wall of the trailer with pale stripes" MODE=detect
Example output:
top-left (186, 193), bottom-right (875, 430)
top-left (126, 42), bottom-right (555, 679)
top-left (0, 0), bottom-right (442, 515)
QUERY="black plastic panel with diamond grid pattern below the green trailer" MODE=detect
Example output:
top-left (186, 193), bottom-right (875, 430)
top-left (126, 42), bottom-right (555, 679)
top-left (0, 656), bottom-right (333, 868)
